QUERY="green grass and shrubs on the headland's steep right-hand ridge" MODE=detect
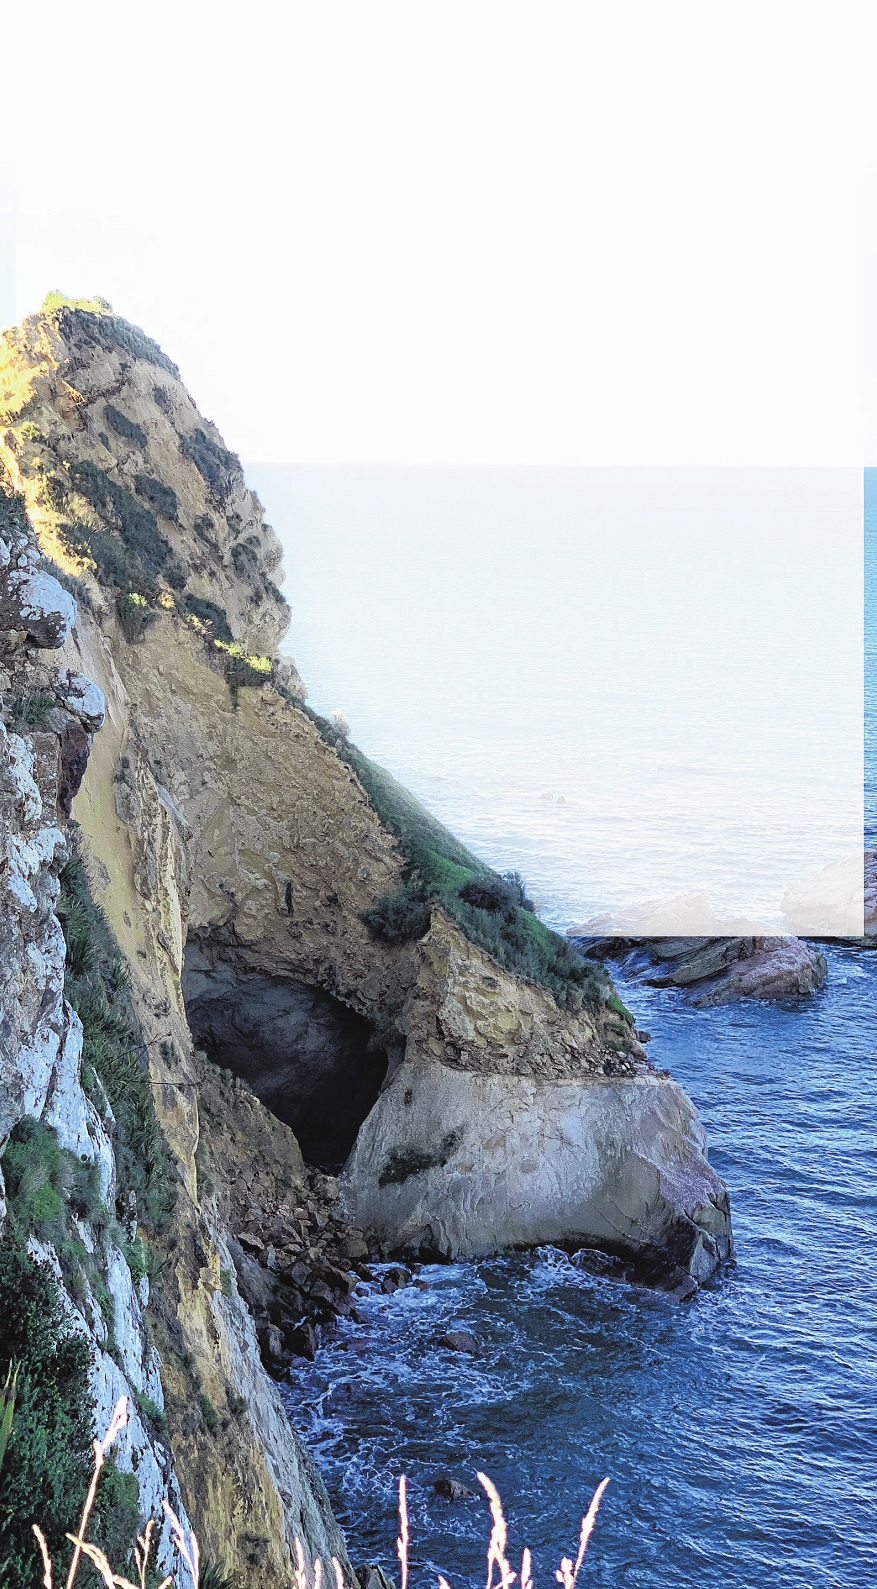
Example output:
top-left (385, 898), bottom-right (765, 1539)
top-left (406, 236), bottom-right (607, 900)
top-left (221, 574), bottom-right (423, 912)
top-left (303, 707), bottom-right (612, 1011)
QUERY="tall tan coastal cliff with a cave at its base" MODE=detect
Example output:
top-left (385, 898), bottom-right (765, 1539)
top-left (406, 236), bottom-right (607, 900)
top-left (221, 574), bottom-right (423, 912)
top-left (0, 300), bottom-right (731, 1586)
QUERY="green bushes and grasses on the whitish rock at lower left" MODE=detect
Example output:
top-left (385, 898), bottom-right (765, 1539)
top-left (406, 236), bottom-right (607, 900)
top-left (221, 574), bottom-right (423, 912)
top-left (0, 853), bottom-right (175, 1589)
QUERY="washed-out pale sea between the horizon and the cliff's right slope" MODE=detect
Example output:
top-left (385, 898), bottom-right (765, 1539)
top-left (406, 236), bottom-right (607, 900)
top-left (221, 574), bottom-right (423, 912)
top-left (248, 466), bottom-right (863, 931)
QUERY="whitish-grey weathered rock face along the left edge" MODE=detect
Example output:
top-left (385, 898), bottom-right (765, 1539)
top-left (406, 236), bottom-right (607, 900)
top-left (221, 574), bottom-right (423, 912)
top-left (0, 499), bottom-right (187, 1572)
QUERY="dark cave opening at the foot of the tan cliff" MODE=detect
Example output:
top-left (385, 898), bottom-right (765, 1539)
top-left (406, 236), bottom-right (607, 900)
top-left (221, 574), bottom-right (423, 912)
top-left (183, 944), bottom-right (388, 1171)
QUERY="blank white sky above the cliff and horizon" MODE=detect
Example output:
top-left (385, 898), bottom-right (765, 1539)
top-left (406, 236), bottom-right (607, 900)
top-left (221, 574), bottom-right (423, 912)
top-left (0, 0), bottom-right (877, 464)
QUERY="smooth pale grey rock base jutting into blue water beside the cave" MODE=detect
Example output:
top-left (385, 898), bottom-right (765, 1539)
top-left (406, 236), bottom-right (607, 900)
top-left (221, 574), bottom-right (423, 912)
top-left (342, 1060), bottom-right (732, 1289)
